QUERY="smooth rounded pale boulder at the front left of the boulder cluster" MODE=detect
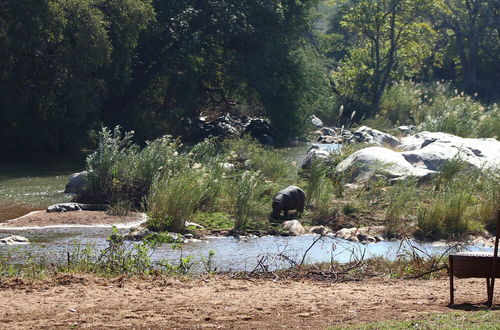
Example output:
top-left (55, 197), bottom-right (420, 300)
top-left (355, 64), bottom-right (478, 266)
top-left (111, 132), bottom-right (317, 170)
top-left (336, 147), bottom-right (433, 182)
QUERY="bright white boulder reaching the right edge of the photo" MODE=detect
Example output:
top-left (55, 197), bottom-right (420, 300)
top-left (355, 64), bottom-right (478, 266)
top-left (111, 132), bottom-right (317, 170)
top-left (400, 132), bottom-right (500, 171)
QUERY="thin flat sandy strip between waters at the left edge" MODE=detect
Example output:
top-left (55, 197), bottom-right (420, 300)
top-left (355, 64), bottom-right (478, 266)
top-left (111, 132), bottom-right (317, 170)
top-left (0, 211), bottom-right (145, 229)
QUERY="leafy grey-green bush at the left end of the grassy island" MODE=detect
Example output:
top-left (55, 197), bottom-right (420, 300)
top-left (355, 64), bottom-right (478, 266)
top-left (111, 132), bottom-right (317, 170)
top-left (83, 127), bottom-right (179, 206)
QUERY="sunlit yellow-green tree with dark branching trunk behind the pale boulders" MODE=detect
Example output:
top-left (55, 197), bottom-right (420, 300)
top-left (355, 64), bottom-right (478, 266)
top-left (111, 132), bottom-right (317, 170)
top-left (334, 0), bottom-right (435, 115)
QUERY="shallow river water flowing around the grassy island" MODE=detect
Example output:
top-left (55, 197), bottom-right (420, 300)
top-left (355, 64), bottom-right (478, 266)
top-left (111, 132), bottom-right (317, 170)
top-left (0, 143), bottom-right (488, 271)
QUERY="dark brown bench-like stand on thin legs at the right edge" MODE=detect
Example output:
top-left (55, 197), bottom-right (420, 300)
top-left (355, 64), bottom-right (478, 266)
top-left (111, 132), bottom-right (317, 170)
top-left (449, 211), bottom-right (500, 307)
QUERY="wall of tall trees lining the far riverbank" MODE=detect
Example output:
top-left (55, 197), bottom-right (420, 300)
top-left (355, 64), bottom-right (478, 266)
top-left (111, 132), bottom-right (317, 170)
top-left (0, 0), bottom-right (500, 153)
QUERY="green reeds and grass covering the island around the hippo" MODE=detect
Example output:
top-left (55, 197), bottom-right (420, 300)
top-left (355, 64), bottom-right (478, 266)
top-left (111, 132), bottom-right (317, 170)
top-left (77, 128), bottom-right (500, 238)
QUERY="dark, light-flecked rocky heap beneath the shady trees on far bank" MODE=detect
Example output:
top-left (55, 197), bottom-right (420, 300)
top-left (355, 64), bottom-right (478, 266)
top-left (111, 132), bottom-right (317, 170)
top-left (183, 114), bottom-right (275, 145)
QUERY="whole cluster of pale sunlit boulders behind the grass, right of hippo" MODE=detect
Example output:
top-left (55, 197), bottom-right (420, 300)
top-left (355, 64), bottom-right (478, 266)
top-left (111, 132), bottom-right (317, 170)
top-left (302, 126), bottom-right (500, 182)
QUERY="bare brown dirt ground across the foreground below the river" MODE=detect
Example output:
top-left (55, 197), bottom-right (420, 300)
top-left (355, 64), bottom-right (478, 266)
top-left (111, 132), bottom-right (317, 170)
top-left (0, 275), bottom-right (500, 329)
